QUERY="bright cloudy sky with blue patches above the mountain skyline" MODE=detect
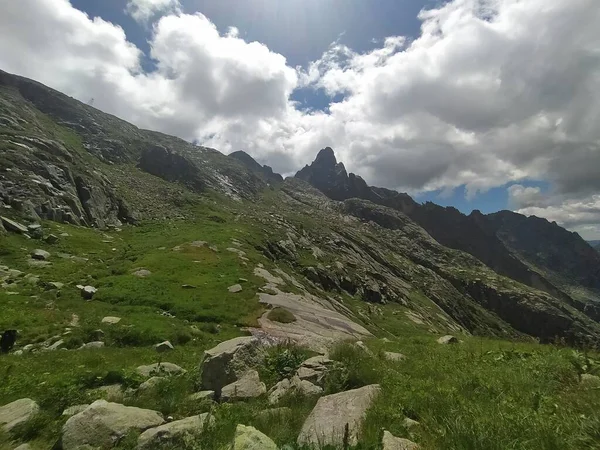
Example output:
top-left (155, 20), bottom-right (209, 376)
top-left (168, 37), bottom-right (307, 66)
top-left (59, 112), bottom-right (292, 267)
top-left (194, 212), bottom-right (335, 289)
top-left (0, 0), bottom-right (600, 239)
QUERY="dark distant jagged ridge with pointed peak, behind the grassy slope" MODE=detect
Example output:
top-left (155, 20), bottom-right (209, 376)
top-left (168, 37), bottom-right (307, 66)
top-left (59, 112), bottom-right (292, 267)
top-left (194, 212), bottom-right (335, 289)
top-left (296, 147), bottom-right (600, 320)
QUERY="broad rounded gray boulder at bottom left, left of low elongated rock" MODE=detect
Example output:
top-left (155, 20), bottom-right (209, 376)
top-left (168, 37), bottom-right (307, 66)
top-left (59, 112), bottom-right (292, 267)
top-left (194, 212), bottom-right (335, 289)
top-left (62, 400), bottom-right (164, 450)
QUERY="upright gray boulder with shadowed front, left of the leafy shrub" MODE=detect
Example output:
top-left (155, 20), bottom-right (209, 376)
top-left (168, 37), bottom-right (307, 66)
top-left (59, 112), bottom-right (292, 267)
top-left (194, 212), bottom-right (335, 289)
top-left (200, 336), bottom-right (262, 395)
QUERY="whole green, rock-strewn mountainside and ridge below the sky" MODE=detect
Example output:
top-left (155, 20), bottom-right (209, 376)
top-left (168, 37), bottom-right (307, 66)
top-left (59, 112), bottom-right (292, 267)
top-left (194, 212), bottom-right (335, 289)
top-left (0, 68), bottom-right (600, 449)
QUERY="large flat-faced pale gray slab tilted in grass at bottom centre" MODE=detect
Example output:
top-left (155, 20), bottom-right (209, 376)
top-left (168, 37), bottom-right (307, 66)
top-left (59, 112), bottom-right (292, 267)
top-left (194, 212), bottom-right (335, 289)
top-left (298, 384), bottom-right (380, 448)
